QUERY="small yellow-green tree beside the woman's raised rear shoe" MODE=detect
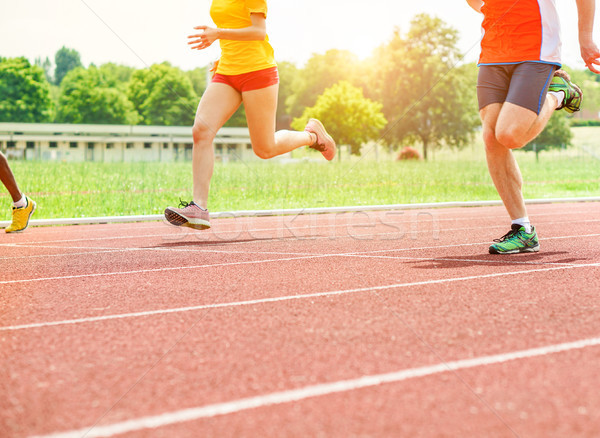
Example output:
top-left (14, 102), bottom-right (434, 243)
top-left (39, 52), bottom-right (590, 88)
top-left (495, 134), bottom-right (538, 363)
top-left (292, 81), bottom-right (386, 155)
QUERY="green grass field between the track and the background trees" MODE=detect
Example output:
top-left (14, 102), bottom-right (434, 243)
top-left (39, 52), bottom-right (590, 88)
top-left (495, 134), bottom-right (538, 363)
top-left (0, 128), bottom-right (600, 220)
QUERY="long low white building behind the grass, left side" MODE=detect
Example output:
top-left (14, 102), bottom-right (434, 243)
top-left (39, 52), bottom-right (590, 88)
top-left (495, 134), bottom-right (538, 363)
top-left (0, 123), bottom-right (259, 162)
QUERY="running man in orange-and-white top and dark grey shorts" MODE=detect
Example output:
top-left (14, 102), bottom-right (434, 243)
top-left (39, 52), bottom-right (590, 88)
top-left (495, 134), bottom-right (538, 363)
top-left (467, 0), bottom-right (600, 254)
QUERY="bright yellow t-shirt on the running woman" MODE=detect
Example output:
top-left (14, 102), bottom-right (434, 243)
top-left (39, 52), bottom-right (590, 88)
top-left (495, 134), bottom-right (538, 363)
top-left (210, 0), bottom-right (277, 75)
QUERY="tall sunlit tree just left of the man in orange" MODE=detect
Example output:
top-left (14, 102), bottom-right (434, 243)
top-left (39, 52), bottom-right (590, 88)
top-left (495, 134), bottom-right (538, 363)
top-left (373, 14), bottom-right (479, 159)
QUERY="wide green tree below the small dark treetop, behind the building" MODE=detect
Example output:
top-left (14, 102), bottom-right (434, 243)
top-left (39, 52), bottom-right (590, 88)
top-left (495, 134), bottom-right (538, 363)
top-left (56, 66), bottom-right (138, 125)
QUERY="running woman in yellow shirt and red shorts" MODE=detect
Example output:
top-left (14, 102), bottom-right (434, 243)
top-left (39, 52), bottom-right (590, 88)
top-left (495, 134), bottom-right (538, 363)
top-left (165, 0), bottom-right (336, 229)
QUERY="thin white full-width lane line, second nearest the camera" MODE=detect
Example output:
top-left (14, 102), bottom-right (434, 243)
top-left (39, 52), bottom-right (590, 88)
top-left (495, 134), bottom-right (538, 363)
top-left (0, 263), bottom-right (600, 331)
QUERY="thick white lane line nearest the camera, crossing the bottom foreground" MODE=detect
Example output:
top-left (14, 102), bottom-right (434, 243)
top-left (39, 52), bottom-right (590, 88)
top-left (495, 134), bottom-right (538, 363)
top-left (31, 338), bottom-right (600, 438)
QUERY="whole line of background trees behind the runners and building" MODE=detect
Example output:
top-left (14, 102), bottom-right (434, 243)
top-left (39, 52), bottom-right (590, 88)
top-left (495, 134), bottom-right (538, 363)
top-left (0, 14), bottom-right (600, 158)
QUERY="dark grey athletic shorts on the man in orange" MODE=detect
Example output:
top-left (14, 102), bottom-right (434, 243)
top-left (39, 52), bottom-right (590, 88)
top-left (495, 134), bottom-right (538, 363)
top-left (477, 62), bottom-right (558, 114)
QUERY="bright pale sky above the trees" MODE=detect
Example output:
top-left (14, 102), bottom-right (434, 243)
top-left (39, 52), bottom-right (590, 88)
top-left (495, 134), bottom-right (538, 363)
top-left (0, 0), bottom-right (598, 70)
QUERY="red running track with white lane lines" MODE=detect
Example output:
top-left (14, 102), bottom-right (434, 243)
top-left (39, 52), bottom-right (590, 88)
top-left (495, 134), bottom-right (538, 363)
top-left (0, 203), bottom-right (600, 437)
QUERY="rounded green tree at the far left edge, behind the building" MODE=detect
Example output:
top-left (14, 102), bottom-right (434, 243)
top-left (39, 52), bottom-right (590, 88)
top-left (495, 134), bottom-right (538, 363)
top-left (0, 58), bottom-right (54, 123)
